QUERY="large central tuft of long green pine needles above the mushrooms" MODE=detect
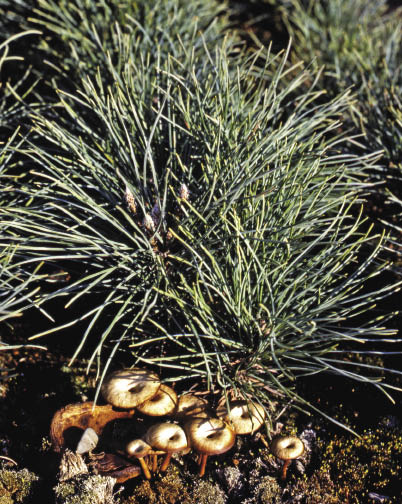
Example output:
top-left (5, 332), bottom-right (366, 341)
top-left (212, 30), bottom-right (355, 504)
top-left (0, 0), bottom-right (396, 430)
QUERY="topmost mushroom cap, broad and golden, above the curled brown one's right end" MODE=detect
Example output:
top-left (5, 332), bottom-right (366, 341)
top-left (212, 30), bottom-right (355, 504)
top-left (101, 368), bottom-right (160, 408)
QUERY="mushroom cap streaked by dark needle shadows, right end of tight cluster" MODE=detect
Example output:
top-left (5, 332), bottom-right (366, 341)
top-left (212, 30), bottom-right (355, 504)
top-left (216, 401), bottom-right (265, 434)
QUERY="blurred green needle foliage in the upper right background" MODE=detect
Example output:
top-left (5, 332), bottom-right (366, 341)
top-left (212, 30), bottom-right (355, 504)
top-left (283, 0), bottom-right (402, 264)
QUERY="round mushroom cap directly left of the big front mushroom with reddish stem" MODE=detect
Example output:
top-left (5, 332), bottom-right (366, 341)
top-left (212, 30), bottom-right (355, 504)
top-left (145, 422), bottom-right (188, 453)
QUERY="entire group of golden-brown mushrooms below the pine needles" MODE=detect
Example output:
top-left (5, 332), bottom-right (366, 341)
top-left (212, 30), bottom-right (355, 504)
top-left (51, 367), bottom-right (304, 481)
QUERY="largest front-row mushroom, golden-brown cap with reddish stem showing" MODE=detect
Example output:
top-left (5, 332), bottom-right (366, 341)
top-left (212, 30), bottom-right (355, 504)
top-left (185, 418), bottom-right (236, 476)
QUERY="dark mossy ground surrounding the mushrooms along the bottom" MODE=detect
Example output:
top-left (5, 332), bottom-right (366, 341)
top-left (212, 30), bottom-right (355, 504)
top-left (0, 342), bottom-right (402, 504)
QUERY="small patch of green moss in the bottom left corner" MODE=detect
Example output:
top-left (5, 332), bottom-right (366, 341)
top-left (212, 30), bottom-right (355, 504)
top-left (0, 469), bottom-right (39, 504)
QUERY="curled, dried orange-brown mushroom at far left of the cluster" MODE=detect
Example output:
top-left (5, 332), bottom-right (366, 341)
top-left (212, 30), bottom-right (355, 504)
top-left (50, 401), bottom-right (134, 452)
